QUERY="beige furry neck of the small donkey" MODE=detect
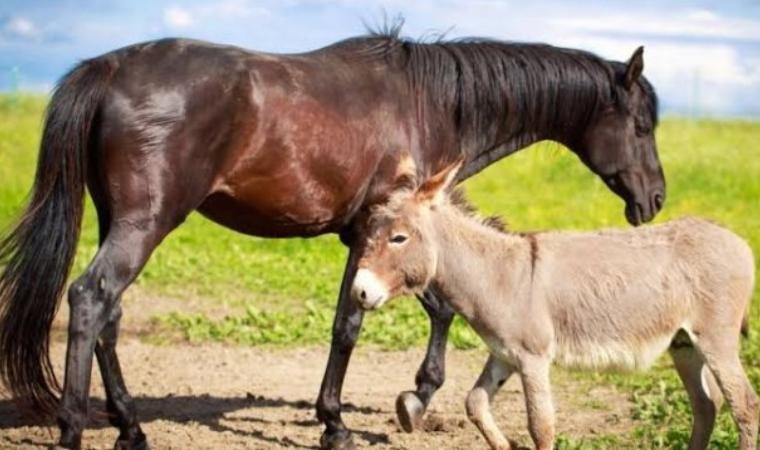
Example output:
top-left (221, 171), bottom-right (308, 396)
top-left (433, 211), bottom-right (530, 319)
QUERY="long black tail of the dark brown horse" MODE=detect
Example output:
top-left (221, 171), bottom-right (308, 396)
top-left (0, 58), bottom-right (114, 415)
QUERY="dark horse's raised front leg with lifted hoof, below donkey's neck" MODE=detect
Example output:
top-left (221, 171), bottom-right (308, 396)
top-left (396, 290), bottom-right (454, 433)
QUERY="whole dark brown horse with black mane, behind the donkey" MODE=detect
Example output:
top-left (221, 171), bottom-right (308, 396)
top-left (0, 27), bottom-right (665, 448)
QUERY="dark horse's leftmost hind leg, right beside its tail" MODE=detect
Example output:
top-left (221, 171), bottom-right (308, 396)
top-left (58, 219), bottom-right (173, 449)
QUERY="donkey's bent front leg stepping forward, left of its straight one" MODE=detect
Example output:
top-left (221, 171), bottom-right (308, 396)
top-left (465, 356), bottom-right (513, 450)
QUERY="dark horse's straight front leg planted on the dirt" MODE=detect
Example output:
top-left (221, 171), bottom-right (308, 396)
top-left (317, 248), bottom-right (364, 450)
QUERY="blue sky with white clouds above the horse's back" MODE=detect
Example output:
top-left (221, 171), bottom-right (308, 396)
top-left (0, 0), bottom-right (760, 118)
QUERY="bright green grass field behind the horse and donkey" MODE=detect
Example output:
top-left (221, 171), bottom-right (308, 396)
top-left (0, 96), bottom-right (760, 449)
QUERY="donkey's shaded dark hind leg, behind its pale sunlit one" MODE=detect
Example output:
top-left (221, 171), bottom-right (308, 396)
top-left (670, 343), bottom-right (723, 450)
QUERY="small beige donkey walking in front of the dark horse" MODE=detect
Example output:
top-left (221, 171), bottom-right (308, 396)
top-left (351, 165), bottom-right (758, 450)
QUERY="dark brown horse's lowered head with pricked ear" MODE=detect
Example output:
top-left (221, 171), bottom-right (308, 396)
top-left (570, 47), bottom-right (665, 225)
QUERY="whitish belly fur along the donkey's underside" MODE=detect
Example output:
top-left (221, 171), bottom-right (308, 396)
top-left (554, 334), bottom-right (673, 371)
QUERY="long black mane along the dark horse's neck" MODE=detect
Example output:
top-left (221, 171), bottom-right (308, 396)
top-left (338, 20), bottom-right (657, 151)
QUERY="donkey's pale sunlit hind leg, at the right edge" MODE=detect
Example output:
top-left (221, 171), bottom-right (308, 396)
top-left (696, 338), bottom-right (760, 450)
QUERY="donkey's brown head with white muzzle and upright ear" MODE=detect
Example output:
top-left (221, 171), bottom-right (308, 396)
top-left (351, 162), bottom-right (461, 309)
